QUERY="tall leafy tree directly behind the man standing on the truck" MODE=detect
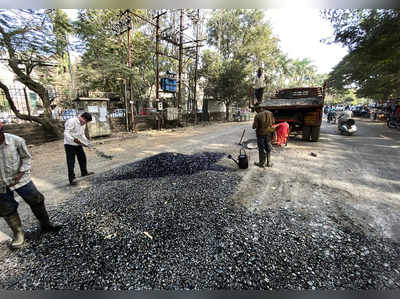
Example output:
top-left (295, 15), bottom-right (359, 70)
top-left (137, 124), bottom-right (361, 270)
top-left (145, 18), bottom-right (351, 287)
top-left (202, 9), bottom-right (280, 117)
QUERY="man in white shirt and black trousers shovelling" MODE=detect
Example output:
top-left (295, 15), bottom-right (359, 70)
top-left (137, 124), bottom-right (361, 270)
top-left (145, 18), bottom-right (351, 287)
top-left (64, 112), bottom-right (94, 186)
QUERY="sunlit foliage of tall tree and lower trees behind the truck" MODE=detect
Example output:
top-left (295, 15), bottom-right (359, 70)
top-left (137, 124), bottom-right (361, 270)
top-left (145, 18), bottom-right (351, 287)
top-left (201, 9), bottom-right (326, 117)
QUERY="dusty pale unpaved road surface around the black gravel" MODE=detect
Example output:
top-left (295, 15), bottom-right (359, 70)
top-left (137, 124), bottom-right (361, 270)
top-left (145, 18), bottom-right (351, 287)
top-left (0, 119), bottom-right (400, 245)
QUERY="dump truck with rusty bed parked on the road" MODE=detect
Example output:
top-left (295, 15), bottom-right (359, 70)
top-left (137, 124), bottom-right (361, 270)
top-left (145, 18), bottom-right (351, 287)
top-left (250, 84), bottom-right (325, 142)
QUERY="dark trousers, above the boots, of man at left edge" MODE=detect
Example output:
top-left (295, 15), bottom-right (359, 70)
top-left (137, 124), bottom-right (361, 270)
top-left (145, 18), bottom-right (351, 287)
top-left (0, 181), bottom-right (44, 217)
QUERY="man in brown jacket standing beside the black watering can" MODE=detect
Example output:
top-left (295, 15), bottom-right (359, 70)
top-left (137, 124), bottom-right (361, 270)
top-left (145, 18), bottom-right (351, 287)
top-left (253, 106), bottom-right (275, 168)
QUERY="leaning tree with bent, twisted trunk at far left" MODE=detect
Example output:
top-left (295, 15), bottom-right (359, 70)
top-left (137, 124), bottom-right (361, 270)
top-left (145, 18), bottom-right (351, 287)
top-left (0, 9), bottom-right (68, 137)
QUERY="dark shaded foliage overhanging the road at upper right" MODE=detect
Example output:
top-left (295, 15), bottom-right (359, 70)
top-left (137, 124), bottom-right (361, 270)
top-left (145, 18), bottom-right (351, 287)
top-left (323, 9), bottom-right (400, 100)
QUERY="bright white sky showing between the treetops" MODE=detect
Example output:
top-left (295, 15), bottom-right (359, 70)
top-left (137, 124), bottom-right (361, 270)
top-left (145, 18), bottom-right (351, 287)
top-left (65, 8), bottom-right (347, 74)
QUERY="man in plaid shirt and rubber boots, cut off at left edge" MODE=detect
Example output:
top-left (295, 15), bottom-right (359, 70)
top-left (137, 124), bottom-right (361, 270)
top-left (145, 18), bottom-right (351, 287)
top-left (0, 121), bottom-right (61, 248)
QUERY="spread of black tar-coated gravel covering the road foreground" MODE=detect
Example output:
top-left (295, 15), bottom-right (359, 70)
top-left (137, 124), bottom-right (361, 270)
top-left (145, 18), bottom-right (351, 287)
top-left (0, 153), bottom-right (400, 290)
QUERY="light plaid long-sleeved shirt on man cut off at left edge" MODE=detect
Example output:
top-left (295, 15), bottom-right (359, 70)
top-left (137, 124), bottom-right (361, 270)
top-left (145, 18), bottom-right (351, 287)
top-left (0, 133), bottom-right (31, 193)
